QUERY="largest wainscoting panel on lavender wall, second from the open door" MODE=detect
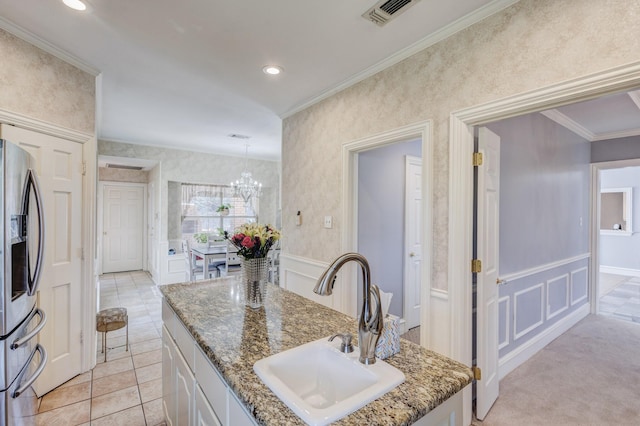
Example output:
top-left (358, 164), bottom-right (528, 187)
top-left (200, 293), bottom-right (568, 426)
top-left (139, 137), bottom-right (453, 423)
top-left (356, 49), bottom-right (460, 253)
top-left (513, 283), bottom-right (544, 340)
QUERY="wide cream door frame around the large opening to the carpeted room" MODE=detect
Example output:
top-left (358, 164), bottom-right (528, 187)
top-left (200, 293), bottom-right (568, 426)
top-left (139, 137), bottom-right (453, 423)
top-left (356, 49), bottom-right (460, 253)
top-left (448, 62), bottom-right (640, 421)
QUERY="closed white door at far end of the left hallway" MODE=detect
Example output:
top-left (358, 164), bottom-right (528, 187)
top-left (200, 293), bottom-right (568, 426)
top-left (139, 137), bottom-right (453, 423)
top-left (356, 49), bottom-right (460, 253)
top-left (102, 183), bottom-right (145, 273)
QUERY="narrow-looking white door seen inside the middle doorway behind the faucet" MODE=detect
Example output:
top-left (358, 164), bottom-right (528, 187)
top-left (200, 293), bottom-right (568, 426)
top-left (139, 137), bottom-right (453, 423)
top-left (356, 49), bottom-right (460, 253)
top-left (404, 156), bottom-right (422, 329)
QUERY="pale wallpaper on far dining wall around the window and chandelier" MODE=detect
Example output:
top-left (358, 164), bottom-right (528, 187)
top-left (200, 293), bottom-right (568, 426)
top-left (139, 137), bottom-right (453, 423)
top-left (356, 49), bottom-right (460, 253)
top-left (98, 141), bottom-right (280, 240)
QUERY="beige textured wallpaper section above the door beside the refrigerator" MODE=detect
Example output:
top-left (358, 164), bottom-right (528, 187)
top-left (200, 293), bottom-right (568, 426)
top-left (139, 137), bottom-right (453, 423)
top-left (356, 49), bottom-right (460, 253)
top-left (0, 30), bottom-right (96, 134)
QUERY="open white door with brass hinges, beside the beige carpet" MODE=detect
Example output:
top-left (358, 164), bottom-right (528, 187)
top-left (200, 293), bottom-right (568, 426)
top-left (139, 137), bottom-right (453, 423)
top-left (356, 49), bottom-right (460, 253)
top-left (476, 127), bottom-right (500, 420)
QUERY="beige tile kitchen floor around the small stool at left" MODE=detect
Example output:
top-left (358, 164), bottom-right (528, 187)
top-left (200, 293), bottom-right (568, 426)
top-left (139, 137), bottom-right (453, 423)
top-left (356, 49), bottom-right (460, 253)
top-left (35, 271), bottom-right (165, 426)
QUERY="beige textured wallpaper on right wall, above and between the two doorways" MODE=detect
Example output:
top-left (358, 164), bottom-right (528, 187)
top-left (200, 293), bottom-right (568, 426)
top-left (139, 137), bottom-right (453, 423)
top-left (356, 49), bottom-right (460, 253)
top-left (282, 0), bottom-right (640, 289)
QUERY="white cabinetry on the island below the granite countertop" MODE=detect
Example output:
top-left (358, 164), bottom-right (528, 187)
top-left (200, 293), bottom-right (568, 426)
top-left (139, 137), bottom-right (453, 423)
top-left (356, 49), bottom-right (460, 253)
top-left (162, 302), bottom-right (256, 426)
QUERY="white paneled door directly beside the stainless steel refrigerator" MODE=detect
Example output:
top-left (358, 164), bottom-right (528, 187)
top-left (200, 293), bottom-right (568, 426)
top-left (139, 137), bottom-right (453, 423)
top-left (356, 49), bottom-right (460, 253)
top-left (2, 126), bottom-right (83, 395)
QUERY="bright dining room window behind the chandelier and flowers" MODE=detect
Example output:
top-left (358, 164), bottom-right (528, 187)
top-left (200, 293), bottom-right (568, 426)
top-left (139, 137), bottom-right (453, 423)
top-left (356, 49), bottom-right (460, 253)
top-left (181, 183), bottom-right (258, 238)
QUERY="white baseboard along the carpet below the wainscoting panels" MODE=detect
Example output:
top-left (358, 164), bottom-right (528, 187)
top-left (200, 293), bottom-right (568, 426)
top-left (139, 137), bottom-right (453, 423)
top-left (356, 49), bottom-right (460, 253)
top-left (498, 303), bottom-right (590, 380)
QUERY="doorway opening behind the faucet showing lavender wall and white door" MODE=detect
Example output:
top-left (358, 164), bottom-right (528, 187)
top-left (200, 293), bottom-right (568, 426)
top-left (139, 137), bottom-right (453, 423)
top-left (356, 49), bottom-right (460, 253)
top-left (357, 139), bottom-right (422, 334)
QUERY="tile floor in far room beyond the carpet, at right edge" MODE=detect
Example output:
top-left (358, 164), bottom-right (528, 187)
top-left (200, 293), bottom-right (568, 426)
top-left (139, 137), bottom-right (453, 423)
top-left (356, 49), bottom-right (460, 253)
top-left (600, 274), bottom-right (640, 323)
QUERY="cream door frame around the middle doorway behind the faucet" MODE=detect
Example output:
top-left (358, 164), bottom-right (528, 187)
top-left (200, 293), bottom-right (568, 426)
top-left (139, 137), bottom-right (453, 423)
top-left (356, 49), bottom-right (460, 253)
top-left (336, 120), bottom-right (433, 347)
